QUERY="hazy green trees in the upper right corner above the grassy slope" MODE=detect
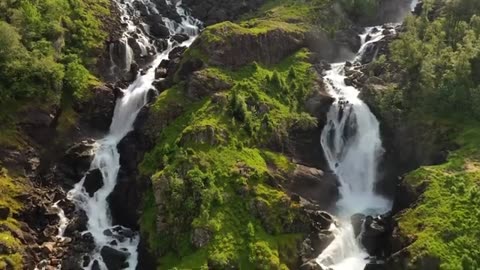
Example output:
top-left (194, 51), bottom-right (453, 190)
top-left (380, 0), bottom-right (480, 118)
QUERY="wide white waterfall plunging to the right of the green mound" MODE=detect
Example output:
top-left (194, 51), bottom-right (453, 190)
top-left (317, 27), bottom-right (391, 270)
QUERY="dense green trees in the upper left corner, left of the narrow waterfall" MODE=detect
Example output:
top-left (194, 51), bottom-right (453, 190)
top-left (0, 0), bottom-right (110, 120)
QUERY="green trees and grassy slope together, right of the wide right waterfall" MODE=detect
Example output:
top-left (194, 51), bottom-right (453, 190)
top-left (364, 0), bottom-right (480, 270)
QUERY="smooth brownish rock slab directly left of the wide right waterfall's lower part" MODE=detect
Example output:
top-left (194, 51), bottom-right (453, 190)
top-left (287, 165), bottom-right (339, 209)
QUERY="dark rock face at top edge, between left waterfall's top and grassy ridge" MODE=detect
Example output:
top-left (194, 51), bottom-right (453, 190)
top-left (183, 0), bottom-right (265, 25)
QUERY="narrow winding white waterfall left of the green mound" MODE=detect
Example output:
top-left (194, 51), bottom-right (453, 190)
top-left (64, 0), bottom-right (199, 270)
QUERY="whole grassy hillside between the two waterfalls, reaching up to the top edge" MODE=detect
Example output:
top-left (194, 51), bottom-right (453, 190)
top-left (135, 0), bottom-right (360, 269)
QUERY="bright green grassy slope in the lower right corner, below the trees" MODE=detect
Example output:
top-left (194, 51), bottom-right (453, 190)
top-left (399, 123), bottom-right (480, 270)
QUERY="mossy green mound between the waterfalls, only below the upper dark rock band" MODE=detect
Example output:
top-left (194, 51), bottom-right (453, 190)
top-left (141, 50), bottom-right (316, 269)
